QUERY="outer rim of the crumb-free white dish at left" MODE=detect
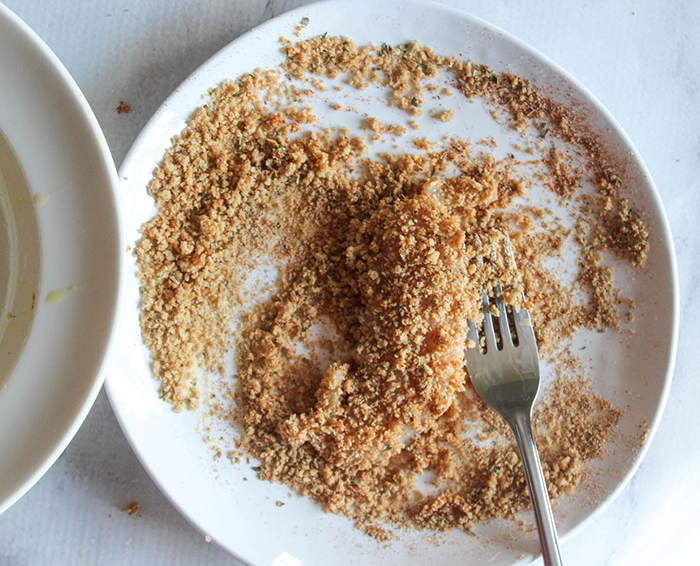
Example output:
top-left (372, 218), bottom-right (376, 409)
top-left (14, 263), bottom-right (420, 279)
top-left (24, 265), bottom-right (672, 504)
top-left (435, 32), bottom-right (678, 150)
top-left (0, 3), bottom-right (125, 515)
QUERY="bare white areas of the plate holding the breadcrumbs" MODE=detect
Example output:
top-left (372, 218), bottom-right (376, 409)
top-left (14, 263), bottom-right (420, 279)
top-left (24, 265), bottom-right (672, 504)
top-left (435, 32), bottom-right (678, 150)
top-left (107, 2), bottom-right (678, 565)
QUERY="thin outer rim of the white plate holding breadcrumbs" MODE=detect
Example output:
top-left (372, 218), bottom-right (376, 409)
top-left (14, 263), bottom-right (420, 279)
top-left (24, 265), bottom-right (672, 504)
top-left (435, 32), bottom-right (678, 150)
top-left (105, 0), bottom-right (680, 563)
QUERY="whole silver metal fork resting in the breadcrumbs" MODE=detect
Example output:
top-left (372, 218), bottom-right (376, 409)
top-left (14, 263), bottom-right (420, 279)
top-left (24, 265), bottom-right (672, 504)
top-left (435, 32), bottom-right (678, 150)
top-left (465, 285), bottom-right (562, 566)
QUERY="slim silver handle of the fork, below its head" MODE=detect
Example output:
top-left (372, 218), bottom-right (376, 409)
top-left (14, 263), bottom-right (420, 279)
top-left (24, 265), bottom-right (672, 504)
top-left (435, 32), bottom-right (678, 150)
top-left (508, 412), bottom-right (562, 566)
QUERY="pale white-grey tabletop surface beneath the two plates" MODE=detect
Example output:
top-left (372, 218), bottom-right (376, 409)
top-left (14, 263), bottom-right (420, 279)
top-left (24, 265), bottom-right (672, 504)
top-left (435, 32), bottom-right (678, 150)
top-left (0, 0), bottom-right (700, 566)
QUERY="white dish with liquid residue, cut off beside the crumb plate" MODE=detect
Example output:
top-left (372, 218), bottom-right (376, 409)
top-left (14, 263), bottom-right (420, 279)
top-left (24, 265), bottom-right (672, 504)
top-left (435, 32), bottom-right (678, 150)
top-left (0, 4), bottom-right (123, 513)
